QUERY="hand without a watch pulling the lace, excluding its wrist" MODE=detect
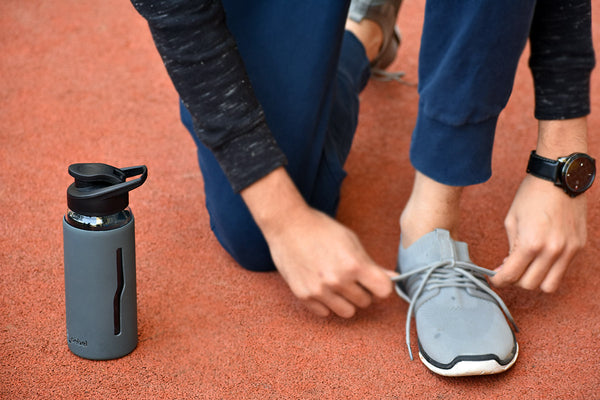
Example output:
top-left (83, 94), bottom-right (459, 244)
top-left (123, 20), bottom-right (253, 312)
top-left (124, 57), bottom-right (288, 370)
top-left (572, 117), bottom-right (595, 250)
top-left (267, 209), bottom-right (392, 318)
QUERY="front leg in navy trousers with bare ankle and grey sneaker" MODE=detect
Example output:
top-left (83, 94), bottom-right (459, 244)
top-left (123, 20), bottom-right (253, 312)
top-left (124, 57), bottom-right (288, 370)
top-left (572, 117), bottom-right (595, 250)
top-left (397, 0), bottom-right (535, 376)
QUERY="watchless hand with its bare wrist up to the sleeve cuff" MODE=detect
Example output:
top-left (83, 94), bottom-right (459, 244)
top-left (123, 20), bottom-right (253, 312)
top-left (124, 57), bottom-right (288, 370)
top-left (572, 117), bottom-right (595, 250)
top-left (241, 168), bottom-right (393, 318)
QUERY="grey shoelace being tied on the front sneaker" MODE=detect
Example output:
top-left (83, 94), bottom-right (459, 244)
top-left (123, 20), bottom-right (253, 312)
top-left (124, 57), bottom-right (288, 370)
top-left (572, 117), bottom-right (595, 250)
top-left (392, 260), bottom-right (519, 360)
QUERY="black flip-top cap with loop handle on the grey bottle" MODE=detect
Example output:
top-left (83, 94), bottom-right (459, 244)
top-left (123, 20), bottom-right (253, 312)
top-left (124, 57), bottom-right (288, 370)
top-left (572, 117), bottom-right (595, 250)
top-left (67, 163), bottom-right (148, 217)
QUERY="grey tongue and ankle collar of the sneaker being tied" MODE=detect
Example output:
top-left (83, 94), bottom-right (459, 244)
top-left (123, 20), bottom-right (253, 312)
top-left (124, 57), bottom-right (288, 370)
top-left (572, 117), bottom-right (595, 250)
top-left (398, 229), bottom-right (471, 273)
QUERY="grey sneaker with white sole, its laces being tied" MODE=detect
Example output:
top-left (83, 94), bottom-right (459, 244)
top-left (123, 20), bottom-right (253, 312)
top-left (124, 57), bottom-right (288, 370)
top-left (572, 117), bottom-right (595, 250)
top-left (393, 229), bottom-right (519, 376)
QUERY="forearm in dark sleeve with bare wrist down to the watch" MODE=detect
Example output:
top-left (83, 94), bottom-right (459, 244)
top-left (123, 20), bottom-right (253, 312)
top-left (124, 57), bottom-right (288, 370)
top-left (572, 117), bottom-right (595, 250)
top-left (529, 0), bottom-right (595, 180)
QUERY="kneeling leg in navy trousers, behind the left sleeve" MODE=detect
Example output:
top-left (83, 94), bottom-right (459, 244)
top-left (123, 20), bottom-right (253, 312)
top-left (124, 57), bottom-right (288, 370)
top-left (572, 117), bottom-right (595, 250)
top-left (181, 1), bottom-right (369, 270)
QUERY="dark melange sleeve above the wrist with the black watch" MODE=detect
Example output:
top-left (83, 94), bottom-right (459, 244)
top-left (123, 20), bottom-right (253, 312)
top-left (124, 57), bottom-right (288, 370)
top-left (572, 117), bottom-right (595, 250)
top-left (529, 0), bottom-right (595, 120)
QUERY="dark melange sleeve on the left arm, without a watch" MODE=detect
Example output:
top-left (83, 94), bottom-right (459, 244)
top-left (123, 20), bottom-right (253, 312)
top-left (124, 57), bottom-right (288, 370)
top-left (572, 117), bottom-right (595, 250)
top-left (132, 0), bottom-right (286, 192)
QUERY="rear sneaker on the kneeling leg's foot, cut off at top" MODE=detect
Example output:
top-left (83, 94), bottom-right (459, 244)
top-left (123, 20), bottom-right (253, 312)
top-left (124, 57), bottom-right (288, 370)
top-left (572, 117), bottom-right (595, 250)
top-left (348, 0), bottom-right (402, 71)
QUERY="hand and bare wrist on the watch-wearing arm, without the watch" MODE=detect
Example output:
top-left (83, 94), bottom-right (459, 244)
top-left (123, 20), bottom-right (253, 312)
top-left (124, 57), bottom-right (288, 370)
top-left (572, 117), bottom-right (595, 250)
top-left (491, 118), bottom-right (587, 292)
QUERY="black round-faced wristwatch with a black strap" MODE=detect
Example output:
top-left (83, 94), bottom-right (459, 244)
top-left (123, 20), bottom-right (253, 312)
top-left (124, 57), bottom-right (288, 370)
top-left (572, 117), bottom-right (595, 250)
top-left (527, 150), bottom-right (596, 197)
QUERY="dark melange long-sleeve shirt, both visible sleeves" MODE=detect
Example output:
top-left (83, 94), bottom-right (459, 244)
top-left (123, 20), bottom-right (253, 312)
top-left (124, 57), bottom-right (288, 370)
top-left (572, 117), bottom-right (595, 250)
top-left (132, 0), bottom-right (595, 191)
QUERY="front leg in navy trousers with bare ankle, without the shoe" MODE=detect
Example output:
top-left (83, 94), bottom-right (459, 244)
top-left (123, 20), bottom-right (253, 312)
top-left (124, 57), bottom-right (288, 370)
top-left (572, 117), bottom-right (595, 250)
top-left (400, 0), bottom-right (535, 246)
